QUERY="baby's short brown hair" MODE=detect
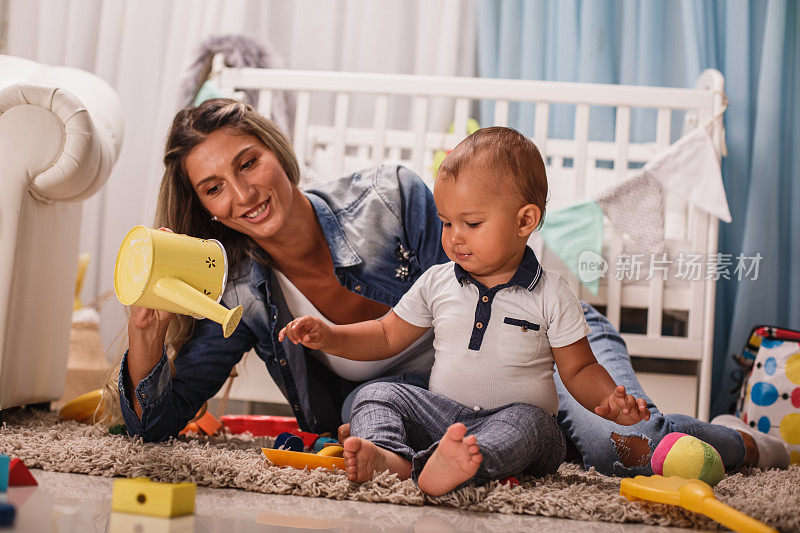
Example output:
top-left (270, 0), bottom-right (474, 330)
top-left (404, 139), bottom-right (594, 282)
top-left (436, 126), bottom-right (547, 229)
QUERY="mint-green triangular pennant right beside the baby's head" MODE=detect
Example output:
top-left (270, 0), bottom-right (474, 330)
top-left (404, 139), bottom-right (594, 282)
top-left (539, 200), bottom-right (603, 294)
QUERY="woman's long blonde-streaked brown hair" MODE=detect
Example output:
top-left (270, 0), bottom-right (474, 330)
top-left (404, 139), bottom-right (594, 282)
top-left (153, 98), bottom-right (300, 356)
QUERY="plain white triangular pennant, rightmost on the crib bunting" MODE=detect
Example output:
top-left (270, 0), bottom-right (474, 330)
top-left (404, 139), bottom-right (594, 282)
top-left (643, 127), bottom-right (731, 222)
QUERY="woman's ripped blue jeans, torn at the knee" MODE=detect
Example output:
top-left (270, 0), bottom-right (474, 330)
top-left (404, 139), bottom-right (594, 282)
top-left (342, 302), bottom-right (745, 476)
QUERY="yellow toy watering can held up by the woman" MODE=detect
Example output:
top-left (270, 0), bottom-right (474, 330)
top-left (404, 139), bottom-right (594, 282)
top-left (114, 226), bottom-right (242, 337)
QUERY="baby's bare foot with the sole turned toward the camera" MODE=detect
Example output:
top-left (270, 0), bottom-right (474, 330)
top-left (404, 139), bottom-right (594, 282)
top-left (417, 423), bottom-right (483, 496)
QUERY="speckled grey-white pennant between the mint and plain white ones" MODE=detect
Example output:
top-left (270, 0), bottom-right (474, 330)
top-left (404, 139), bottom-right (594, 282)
top-left (595, 168), bottom-right (664, 253)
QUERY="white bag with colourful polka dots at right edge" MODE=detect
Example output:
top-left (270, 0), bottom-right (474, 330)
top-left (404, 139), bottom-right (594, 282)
top-left (737, 326), bottom-right (800, 464)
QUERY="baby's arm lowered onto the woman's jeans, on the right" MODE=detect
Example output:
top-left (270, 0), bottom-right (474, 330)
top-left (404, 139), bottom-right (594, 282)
top-left (553, 337), bottom-right (650, 426)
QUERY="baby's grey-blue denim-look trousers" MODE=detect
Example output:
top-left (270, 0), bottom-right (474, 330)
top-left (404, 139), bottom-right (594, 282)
top-left (350, 382), bottom-right (566, 483)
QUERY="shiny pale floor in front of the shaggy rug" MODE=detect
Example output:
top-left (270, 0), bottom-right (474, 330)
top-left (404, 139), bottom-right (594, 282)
top-left (0, 470), bottom-right (700, 533)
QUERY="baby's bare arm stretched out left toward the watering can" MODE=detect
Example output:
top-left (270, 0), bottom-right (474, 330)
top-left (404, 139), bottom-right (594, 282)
top-left (278, 311), bottom-right (429, 361)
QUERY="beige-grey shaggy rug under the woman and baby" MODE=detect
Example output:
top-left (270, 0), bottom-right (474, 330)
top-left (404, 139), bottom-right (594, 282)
top-left (0, 410), bottom-right (800, 531)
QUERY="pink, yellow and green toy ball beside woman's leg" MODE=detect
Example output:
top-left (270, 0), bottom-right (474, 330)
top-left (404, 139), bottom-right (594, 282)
top-left (650, 432), bottom-right (725, 487)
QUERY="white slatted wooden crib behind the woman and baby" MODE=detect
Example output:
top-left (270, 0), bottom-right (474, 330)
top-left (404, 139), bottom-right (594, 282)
top-left (205, 58), bottom-right (725, 419)
